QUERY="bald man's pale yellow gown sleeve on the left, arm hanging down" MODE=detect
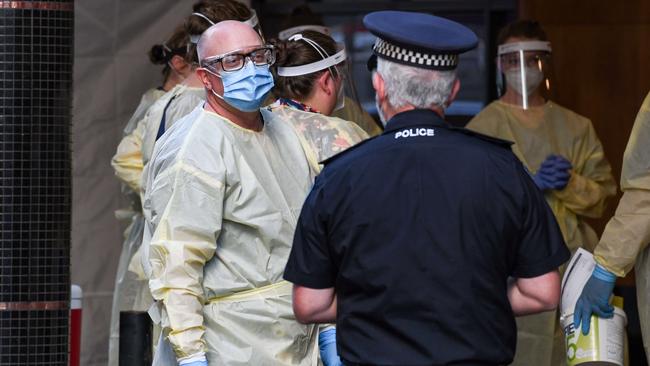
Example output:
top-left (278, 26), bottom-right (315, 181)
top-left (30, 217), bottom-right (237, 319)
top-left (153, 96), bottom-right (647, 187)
top-left (147, 161), bottom-right (225, 362)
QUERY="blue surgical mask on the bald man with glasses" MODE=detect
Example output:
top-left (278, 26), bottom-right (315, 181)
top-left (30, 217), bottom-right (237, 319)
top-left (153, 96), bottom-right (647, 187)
top-left (212, 60), bottom-right (274, 112)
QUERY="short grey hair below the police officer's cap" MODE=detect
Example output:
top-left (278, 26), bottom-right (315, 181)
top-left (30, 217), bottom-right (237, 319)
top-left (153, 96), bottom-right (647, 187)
top-left (377, 58), bottom-right (456, 110)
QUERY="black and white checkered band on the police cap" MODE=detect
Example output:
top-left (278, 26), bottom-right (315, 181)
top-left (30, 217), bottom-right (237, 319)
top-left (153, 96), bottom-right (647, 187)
top-left (373, 38), bottom-right (458, 70)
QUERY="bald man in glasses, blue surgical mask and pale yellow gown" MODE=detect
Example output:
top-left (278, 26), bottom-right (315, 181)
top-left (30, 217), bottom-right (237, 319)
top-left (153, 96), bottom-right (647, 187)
top-left (143, 21), bottom-right (319, 366)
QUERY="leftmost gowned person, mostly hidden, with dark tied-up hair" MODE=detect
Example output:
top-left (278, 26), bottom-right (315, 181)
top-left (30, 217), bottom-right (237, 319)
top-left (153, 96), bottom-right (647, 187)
top-left (108, 25), bottom-right (190, 366)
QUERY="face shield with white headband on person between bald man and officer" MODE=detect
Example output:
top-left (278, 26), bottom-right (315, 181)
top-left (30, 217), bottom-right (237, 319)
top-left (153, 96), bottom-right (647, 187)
top-left (278, 34), bottom-right (357, 111)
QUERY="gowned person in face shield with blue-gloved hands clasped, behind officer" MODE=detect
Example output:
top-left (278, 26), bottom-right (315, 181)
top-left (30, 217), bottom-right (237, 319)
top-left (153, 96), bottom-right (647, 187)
top-left (467, 20), bottom-right (616, 366)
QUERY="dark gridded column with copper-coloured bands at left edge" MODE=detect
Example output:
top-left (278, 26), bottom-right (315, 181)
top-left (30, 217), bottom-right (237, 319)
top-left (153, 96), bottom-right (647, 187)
top-left (0, 0), bottom-right (74, 366)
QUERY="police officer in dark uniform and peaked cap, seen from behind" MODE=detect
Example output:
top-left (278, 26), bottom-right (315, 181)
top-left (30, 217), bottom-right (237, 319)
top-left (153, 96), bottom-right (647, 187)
top-left (284, 11), bottom-right (569, 366)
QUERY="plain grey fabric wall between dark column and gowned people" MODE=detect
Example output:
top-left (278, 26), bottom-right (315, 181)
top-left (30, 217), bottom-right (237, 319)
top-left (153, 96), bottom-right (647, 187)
top-left (71, 0), bottom-right (194, 366)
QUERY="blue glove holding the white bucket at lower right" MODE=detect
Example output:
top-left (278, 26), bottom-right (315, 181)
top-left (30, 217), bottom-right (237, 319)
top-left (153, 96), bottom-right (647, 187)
top-left (573, 264), bottom-right (616, 335)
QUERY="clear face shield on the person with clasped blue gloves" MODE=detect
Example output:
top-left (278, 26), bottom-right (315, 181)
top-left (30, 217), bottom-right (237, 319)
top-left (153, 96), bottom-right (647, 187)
top-left (497, 41), bottom-right (552, 109)
